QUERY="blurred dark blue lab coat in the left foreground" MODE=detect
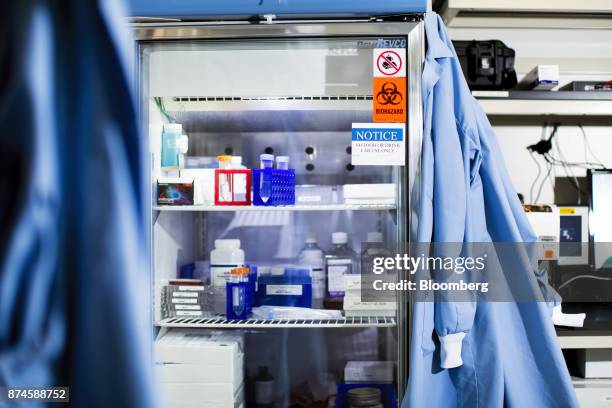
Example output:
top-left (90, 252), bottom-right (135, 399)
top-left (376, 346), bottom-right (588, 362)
top-left (0, 0), bottom-right (155, 407)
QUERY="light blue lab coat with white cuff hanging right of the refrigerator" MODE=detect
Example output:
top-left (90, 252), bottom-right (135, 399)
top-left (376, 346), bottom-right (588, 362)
top-left (402, 13), bottom-right (577, 408)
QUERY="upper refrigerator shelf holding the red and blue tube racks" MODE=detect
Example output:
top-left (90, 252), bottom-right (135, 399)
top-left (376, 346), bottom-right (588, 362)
top-left (153, 204), bottom-right (397, 212)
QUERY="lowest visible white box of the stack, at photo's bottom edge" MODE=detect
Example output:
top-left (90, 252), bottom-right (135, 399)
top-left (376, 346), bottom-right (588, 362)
top-left (162, 383), bottom-right (244, 408)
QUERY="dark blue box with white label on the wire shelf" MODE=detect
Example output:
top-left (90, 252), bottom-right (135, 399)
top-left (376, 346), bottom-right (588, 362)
top-left (257, 267), bottom-right (312, 307)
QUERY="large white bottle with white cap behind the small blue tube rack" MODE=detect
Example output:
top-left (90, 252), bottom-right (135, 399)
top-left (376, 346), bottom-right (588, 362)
top-left (210, 239), bottom-right (244, 314)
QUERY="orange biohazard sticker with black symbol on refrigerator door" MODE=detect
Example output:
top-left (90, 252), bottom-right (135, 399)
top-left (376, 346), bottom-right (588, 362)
top-left (372, 78), bottom-right (406, 123)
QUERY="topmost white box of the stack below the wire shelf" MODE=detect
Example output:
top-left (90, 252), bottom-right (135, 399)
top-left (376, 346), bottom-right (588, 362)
top-left (154, 329), bottom-right (244, 367)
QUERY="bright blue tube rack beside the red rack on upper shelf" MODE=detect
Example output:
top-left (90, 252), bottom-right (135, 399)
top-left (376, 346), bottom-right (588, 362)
top-left (253, 169), bottom-right (295, 207)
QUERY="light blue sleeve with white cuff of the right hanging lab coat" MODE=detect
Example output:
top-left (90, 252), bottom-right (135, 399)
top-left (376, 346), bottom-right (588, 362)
top-left (420, 13), bottom-right (477, 368)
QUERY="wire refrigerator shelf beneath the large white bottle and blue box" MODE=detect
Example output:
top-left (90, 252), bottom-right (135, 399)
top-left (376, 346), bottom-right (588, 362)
top-left (157, 317), bottom-right (396, 329)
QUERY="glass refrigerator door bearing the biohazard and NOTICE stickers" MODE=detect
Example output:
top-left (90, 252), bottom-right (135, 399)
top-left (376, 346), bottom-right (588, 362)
top-left (137, 23), bottom-right (421, 407)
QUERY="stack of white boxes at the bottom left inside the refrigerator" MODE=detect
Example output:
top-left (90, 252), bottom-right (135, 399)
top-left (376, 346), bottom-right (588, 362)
top-left (155, 329), bottom-right (244, 408)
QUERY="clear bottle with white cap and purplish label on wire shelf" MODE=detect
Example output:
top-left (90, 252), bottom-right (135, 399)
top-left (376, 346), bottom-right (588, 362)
top-left (325, 232), bottom-right (359, 309)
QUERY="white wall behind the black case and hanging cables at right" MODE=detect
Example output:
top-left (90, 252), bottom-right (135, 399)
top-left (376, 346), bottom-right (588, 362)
top-left (449, 28), bottom-right (612, 203)
